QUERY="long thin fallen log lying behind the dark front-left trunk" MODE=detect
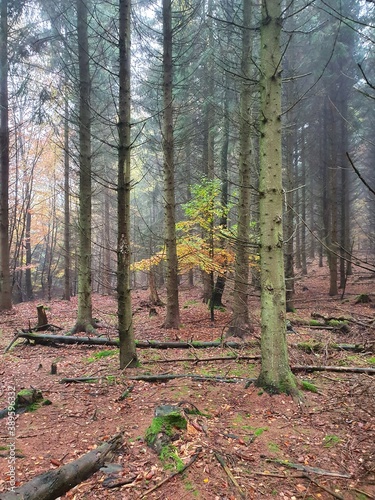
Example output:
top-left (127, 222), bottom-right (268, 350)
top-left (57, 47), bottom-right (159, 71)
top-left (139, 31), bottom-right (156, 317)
top-left (4, 332), bottom-right (252, 352)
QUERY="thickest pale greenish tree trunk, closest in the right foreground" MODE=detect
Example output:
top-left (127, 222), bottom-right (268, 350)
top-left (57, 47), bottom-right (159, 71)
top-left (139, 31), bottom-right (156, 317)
top-left (257, 0), bottom-right (298, 395)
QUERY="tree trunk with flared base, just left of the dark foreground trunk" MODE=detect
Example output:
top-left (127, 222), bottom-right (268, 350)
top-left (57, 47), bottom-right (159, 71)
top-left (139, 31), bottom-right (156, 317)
top-left (73, 0), bottom-right (94, 333)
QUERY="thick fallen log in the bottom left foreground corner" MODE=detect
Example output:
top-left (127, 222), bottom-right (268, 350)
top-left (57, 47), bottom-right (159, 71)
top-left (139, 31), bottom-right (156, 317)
top-left (0, 433), bottom-right (123, 500)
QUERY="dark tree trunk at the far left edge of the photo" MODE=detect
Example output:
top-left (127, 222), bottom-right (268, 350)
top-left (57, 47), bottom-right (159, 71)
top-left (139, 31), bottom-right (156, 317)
top-left (0, 0), bottom-right (12, 311)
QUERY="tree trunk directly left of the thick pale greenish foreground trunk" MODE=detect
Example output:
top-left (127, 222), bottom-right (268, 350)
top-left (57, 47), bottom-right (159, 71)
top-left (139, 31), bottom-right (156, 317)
top-left (227, 0), bottom-right (252, 337)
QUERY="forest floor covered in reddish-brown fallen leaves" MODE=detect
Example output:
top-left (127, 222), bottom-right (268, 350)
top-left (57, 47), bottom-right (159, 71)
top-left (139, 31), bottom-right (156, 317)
top-left (0, 268), bottom-right (375, 500)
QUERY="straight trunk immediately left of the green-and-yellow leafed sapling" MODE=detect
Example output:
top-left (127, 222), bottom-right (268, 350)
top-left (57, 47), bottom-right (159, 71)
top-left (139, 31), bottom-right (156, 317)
top-left (163, 0), bottom-right (180, 328)
